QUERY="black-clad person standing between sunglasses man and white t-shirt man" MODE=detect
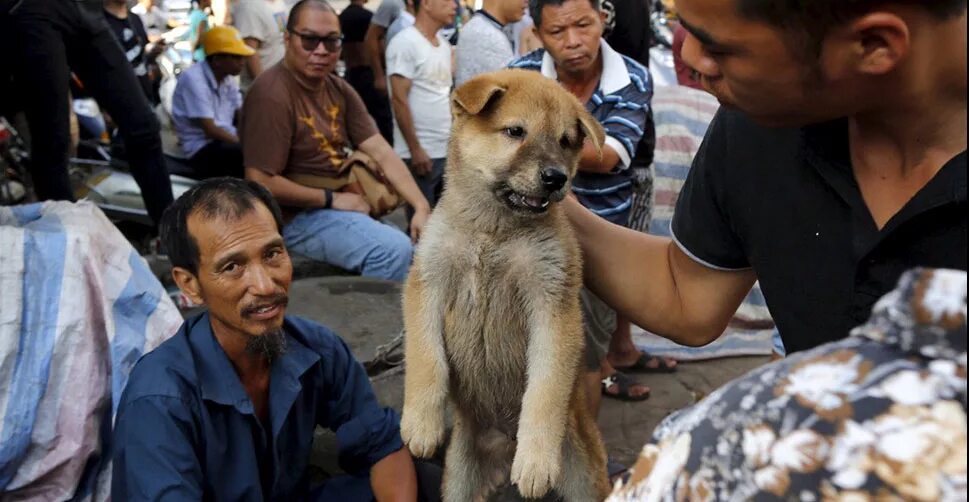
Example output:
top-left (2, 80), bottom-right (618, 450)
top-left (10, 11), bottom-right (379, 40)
top-left (340, 0), bottom-right (394, 144)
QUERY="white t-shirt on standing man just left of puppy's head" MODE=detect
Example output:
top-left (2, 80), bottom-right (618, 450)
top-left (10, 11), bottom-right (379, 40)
top-left (387, 26), bottom-right (452, 159)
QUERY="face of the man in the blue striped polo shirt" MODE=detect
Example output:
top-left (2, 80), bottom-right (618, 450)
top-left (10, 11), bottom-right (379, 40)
top-left (535, 0), bottom-right (603, 73)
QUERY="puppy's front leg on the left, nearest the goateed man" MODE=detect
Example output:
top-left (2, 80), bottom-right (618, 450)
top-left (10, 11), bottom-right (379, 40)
top-left (400, 270), bottom-right (448, 457)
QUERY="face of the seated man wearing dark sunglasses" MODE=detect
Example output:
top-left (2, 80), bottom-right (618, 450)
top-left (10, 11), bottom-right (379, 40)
top-left (285, 7), bottom-right (341, 80)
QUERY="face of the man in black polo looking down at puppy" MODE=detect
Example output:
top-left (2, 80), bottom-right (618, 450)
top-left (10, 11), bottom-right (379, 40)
top-left (676, 0), bottom-right (851, 126)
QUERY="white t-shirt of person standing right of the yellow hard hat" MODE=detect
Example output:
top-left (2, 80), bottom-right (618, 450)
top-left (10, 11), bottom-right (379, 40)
top-left (232, 0), bottom-right (286, 89)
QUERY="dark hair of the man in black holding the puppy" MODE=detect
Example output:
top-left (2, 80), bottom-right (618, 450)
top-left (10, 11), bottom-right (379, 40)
top-left (736, 0), bottom-right (966, 52)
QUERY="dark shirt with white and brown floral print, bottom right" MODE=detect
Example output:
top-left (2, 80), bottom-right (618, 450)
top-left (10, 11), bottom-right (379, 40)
top-left (609, 269), bottom-right (966, 502)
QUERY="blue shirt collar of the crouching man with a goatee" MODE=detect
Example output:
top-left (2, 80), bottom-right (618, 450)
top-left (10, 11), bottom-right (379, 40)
top-left (182, 312), bottom-right (320, 424)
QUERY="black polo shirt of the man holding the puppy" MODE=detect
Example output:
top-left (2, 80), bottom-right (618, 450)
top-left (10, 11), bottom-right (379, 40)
top-left (672, 109), bottom-right (967, 352)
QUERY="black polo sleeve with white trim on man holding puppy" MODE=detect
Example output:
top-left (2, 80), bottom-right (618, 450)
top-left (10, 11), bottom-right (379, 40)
top-left (671, 109), bottom-right (750, 270)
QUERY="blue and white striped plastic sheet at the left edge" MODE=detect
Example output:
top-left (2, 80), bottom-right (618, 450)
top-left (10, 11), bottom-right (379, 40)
top-left (0, 202), bottom-right (182, 500)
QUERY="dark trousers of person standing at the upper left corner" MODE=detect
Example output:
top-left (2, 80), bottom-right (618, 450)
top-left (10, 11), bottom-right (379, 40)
top-left (0, 0), bottom-right (173, 223)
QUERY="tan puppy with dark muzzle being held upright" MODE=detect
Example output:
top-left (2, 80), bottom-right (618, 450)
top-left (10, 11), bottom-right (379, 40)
top-left (401, 70), bottom-right (609, 502)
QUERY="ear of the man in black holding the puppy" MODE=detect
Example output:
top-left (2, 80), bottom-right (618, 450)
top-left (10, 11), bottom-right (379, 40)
top-left (849, 12), bottom-right (912, 75)
